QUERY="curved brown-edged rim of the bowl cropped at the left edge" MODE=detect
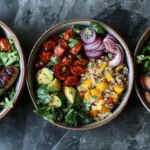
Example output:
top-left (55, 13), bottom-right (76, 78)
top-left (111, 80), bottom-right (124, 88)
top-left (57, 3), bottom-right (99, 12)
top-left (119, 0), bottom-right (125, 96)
top-left (0, 20), bottom-right (26, 120)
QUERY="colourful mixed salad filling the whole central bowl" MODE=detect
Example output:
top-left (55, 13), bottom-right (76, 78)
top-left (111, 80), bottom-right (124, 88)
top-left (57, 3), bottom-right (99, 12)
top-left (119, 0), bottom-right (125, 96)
top-left (35, 22), bottom-right (128, 126)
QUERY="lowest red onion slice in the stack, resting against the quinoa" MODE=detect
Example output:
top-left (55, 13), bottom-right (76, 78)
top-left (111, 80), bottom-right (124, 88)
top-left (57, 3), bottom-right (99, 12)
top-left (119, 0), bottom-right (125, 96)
top-left (85, 50), bottom-right (103, 58)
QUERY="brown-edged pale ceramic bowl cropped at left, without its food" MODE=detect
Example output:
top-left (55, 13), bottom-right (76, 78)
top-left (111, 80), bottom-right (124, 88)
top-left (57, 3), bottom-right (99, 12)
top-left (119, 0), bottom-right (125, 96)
top-left (0, 20), bottom-right (26, 119)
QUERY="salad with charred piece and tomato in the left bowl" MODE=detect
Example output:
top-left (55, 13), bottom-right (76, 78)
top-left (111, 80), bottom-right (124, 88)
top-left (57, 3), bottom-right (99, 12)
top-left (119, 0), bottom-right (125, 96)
top-left (0, 31), bottom-right (19, 109)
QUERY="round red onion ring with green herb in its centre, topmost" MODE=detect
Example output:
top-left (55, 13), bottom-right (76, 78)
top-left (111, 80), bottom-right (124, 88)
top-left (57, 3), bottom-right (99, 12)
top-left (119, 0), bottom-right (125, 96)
top-left (81, 27), bottom-right (96, 44)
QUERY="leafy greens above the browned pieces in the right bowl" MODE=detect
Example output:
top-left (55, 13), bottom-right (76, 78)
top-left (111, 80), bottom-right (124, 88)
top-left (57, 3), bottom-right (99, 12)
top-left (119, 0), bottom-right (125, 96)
top-left (137, 41), bottom-right (150, 71)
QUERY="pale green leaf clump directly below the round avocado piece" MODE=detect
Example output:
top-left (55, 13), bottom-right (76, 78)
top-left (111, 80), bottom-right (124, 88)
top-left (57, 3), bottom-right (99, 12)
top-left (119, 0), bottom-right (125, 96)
top-left (36, 85), bottom-right (52, 104)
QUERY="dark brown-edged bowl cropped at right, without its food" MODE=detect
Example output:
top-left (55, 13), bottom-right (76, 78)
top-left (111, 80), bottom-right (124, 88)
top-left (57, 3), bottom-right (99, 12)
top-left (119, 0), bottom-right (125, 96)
top-left (134, 27), bottom-right (150, 112)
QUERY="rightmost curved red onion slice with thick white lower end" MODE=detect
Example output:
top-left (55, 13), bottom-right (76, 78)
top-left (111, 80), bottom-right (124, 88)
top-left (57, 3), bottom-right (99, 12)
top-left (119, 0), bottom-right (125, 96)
top-left (109, 44), bottom-right (124, 67)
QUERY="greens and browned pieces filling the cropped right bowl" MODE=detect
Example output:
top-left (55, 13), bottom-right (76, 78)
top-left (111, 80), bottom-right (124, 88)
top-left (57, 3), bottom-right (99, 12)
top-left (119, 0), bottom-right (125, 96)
top-left (137, 41), bottom-right (150, 104)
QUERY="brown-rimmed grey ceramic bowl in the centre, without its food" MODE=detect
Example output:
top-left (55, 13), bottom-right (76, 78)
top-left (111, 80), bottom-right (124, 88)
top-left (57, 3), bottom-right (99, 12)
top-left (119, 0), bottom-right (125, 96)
top-left (27, 19), bottom-right (134, 130)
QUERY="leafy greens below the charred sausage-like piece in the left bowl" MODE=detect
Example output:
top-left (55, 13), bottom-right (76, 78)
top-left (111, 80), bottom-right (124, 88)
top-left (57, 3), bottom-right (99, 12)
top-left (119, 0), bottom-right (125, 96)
top-left (0, 88), bottom-right (15, 108)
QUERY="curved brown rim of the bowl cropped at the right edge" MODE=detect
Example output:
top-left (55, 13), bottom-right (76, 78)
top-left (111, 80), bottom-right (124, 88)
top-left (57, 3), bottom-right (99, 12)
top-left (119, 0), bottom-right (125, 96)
top-left (133, 27), bottom-right (150, 112)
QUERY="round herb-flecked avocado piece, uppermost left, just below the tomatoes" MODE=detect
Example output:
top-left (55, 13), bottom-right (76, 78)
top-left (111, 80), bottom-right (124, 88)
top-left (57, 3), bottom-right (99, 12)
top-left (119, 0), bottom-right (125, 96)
top-left (37, 68), bottom-right (53, 85)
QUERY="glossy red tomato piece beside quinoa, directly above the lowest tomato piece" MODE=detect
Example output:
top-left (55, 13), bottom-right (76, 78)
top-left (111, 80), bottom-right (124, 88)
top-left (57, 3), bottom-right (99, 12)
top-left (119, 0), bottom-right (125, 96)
top-left (70, 66), bottom-right (85, 76)
